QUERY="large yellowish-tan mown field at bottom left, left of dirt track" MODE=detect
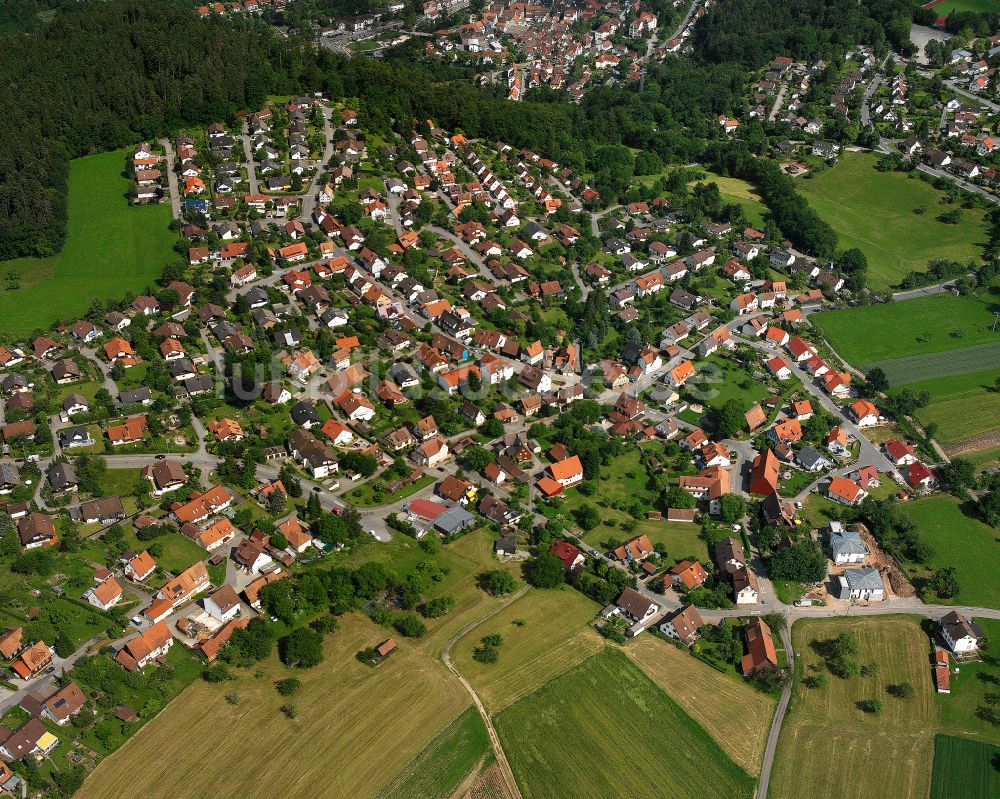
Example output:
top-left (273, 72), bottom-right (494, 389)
top-left (76, 615), bottom-right (471, 799)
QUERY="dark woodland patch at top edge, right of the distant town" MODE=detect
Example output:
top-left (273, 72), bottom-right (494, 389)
top-left (694, 0), bottom-right (913, 68)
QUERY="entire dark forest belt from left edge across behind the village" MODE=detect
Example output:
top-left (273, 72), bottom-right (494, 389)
top-left (0, 0), bottom-right (909, 259)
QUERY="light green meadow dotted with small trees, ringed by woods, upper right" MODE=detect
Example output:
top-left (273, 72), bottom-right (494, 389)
top-left (797, 153), bottom-right (987, 291)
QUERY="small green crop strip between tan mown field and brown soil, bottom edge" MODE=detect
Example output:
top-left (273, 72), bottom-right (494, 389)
top-left (376, 707), bottom-right (490, 799)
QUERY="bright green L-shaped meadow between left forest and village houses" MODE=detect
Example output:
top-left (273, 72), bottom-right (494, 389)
top-left (0, 150), bottom-right (178, 335)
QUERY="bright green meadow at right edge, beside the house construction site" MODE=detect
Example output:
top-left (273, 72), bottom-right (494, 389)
top-left (903, 495), bottom-right (1000, 608)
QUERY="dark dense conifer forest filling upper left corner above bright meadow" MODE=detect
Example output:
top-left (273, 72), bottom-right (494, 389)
top-left (0, 2), bottom-right (315, 258)
